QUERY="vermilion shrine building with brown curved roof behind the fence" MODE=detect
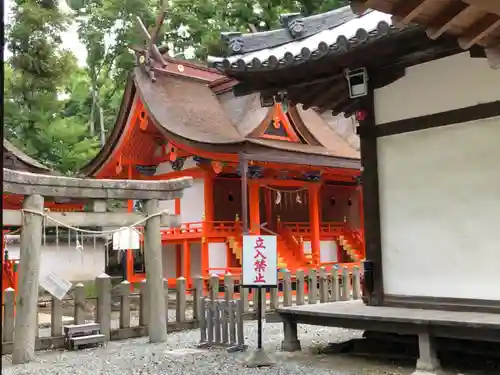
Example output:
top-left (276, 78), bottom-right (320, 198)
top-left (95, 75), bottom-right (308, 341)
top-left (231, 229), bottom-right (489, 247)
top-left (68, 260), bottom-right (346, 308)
top-left (82, 57), bottom-right (364, 282)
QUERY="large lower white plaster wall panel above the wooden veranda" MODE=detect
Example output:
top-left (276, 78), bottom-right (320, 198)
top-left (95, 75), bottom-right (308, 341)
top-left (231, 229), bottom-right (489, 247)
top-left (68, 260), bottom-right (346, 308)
top-left (378, 116), bottom-right (500, 300)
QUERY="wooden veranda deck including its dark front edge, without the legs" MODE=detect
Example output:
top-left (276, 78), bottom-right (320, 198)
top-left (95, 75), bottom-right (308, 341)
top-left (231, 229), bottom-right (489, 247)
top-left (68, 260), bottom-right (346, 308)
top-left (276, 301), bottom-right (500, 342)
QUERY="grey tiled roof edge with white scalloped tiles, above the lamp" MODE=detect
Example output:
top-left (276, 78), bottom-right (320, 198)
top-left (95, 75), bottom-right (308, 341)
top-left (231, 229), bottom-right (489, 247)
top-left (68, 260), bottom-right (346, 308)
top-left (208, 7), bottom-right (402, 75)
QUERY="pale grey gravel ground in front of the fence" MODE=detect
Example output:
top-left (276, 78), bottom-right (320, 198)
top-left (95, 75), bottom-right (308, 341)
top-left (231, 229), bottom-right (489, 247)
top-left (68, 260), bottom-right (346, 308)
top-left (2, 322), bottom-right (418, 375)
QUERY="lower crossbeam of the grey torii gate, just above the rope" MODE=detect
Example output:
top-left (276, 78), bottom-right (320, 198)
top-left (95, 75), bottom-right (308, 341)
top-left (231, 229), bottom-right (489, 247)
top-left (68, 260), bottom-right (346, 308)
top-left (2, 210), bottom-right (180, 228)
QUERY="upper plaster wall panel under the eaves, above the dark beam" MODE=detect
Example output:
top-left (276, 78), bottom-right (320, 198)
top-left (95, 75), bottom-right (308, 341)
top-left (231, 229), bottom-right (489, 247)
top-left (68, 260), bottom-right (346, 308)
top-left (375, 52), bottom-right (500, 124)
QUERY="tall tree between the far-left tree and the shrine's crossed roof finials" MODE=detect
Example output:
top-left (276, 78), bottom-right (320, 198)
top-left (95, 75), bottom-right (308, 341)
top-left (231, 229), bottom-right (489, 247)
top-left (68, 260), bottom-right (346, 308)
top-left (68, 0), bottom-right (157, 132)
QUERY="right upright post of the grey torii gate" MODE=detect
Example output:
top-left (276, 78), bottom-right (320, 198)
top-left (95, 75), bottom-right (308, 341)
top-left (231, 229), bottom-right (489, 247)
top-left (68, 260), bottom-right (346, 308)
top-left (144, 199), bottom-right (167, 342)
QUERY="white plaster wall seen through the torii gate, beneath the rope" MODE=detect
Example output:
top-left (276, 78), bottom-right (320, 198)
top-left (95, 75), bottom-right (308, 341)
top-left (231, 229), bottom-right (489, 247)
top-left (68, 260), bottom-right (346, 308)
top-left (7, 243), bottom-right (106, 282)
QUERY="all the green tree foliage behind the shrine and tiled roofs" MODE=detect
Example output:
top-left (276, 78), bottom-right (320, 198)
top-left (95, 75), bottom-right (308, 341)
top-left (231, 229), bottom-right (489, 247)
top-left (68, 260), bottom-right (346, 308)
top-left (4, 0), bottom-right (348, 173)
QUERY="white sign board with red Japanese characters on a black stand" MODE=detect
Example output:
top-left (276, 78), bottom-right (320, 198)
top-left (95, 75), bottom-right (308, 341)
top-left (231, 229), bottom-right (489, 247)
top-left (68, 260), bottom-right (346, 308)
top-left (242, 236), bottom-right (278, 286)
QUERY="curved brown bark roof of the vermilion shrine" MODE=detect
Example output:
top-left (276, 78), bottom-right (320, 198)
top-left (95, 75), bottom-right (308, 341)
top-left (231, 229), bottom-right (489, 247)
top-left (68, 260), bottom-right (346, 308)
top-left (81, 60), bottom-right (360, 175)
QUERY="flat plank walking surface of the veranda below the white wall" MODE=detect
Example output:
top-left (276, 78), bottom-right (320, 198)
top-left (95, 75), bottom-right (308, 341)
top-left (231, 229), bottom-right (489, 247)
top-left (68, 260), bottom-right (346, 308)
top-left (276, 300), bottom-right (500, 329)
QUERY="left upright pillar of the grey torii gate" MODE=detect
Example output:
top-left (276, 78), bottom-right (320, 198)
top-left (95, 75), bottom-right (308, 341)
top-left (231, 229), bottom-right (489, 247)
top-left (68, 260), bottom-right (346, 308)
top-left (12, 195), bottom-right (44, 364)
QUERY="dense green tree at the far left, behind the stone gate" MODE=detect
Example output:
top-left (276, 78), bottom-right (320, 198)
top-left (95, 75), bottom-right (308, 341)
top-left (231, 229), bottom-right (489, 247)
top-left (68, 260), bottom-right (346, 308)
top-left (4, 0), bottom-right (96, 173)
